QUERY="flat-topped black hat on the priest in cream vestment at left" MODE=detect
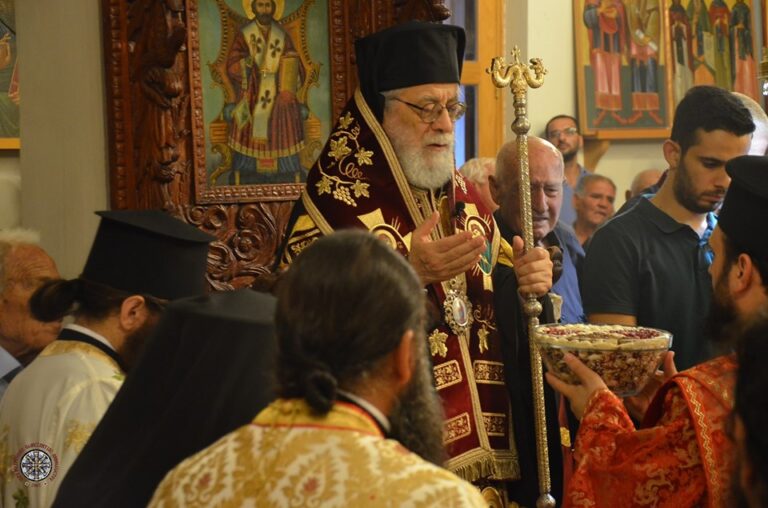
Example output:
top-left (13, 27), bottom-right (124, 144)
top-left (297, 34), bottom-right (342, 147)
top-left (80, 210), bottom-right (215, 300)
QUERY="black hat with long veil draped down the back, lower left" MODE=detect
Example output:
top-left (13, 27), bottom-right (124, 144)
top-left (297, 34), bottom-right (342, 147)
top-left (53, 289), bottom-right (277, 508)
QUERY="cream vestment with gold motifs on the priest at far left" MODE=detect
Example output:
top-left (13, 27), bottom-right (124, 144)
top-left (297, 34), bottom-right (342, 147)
top-left (0, 328), bottom-right (125, 508)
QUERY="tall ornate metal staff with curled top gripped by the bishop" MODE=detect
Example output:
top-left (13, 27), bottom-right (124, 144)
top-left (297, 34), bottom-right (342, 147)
top-left (486, 46), bottom-right (555, 508)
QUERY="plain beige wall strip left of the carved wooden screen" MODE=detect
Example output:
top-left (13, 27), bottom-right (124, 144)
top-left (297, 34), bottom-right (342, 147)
top-left (16, 0), bottom-right (108, 277)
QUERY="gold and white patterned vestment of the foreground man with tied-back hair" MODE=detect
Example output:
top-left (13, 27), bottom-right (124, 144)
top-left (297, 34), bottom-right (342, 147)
top-left (150, 399), bottom-right (487, 508)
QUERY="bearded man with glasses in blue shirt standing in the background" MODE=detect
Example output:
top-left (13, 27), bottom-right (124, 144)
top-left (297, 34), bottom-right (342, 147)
top-left (544, 115), bottom-right (590, 225)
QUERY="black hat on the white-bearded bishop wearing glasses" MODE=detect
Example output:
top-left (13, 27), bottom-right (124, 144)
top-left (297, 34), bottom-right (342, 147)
top-left (355, 21), bottom-right (466, 120)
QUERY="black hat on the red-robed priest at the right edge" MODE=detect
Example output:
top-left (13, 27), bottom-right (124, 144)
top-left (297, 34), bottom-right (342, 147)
top-left (718, 155), bottom-right (768, 257)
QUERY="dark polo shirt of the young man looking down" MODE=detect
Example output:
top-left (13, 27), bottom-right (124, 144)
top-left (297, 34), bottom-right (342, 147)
top-left (581, 198), bottom-right (716, 370)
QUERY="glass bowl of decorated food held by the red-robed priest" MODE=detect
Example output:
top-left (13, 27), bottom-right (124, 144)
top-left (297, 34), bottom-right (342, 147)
top-left (533, 324), bottom-right (672, 397)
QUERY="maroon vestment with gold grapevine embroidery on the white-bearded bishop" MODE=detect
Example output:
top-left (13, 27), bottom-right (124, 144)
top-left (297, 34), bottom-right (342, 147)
top-left (280, 90), bottom-right (520, 482)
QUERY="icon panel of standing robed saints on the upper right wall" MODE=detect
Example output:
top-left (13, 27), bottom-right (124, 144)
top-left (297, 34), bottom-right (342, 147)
top-left (574, 0), bottom-right (758, 139)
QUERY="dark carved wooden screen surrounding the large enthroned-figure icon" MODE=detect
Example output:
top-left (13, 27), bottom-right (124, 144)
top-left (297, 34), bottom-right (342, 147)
top-left (102, 0), bottom-right (450, 290)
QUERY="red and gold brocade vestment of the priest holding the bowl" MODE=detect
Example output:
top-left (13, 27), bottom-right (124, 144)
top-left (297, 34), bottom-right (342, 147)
top-left (563, 356), bottom-right (736, 508)
